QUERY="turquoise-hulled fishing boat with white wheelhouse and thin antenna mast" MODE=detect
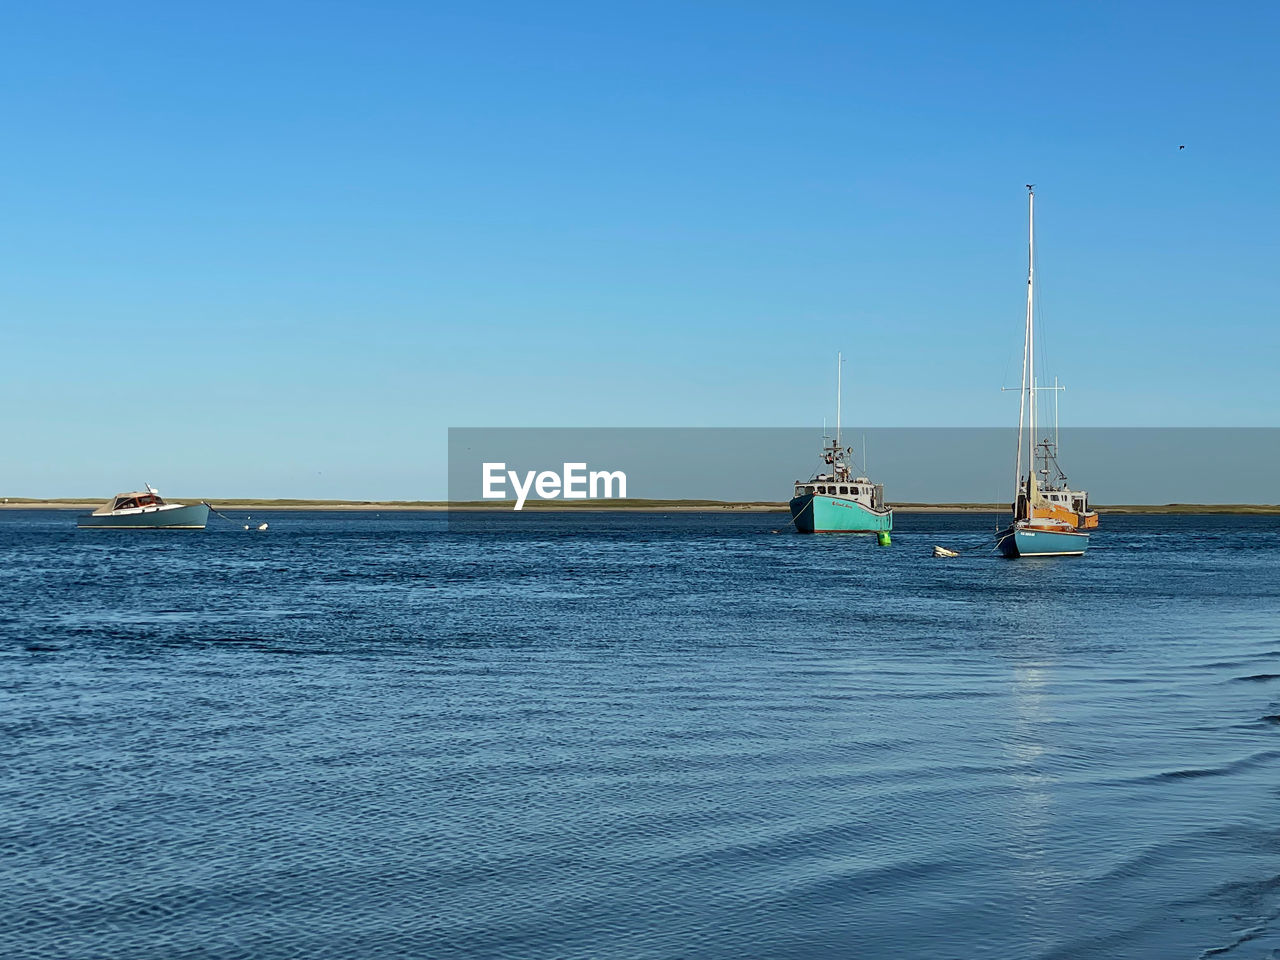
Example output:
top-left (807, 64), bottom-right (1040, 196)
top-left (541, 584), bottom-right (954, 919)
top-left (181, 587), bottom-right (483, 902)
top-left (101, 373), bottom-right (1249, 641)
top-left (790, 353), bottom-right (893, 543)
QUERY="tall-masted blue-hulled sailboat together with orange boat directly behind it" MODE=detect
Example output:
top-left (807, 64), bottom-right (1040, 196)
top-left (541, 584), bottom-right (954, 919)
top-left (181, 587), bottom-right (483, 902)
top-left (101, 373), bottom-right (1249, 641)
top-left (996, 183), bottom-right (1098, 557)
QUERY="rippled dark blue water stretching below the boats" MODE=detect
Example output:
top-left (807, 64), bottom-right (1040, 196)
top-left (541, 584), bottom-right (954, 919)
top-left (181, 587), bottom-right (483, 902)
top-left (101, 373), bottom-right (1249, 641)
top-left (0, 511), bottom-right (1280, 960)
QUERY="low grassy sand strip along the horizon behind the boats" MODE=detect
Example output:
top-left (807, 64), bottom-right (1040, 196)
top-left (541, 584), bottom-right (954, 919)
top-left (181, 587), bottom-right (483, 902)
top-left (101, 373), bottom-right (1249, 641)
top-left (0, 497), bottom-right (1280, 516)
